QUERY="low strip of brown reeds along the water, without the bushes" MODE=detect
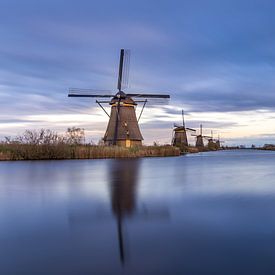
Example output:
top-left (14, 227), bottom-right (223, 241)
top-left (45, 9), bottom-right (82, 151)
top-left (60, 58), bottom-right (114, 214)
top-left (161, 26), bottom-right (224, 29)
top-left (0, 144), bottom-right (180, 160)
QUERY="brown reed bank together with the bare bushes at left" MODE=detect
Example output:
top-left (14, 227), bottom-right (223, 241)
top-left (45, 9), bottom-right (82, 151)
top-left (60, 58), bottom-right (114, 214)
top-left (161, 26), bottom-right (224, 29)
top-left (0, 127), bottom-right (180, 160)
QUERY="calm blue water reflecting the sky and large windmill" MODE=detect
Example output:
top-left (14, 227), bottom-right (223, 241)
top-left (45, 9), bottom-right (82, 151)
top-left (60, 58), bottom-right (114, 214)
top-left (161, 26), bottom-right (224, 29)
top-left (0, 150), bottom-right (275, 275)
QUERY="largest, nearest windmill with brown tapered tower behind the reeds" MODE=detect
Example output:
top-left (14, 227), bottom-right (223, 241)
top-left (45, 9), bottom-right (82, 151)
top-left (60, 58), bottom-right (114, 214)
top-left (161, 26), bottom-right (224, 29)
top-left (68, 49), bottom-right (170, 147)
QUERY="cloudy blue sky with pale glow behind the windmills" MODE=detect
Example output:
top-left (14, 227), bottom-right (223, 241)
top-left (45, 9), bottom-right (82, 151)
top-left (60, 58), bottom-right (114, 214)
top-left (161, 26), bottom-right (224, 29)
top-left (0, 0), bottom-right (275, 145)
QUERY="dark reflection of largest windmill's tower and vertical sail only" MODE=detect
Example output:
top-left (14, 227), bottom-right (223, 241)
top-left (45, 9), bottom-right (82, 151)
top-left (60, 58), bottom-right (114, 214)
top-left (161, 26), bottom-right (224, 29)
top-left (109, 159), bottom-right (140, 264)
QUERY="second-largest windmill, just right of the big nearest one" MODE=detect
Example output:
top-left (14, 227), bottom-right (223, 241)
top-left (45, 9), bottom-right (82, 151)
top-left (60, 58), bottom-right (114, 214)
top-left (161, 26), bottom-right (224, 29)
top-left (172, 110), bottom-right (196, 149)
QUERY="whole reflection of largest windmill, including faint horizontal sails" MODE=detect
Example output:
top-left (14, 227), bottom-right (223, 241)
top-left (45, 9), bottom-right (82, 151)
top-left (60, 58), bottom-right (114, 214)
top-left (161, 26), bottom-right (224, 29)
top-left (68, 159), bottom-right (169, 264)
